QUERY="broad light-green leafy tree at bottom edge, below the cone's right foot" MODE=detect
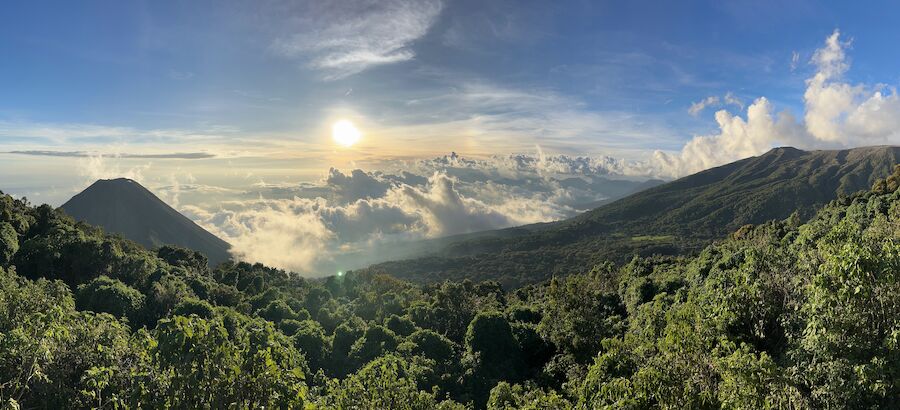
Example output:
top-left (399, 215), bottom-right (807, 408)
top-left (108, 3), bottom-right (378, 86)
top-left (153, 316), bottom-right (306, 408)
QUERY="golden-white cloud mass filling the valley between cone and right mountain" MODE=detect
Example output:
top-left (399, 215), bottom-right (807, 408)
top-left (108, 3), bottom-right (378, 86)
top-left (181, 148), bottom-right (652, 275)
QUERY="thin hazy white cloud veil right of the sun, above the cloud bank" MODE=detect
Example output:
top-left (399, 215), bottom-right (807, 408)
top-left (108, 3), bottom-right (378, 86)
top-left (390, 81), bottom-right (677, 155)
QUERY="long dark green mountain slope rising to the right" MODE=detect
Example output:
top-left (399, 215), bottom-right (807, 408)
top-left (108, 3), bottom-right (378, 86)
top-left (368, 146), bottom-right (900, 286)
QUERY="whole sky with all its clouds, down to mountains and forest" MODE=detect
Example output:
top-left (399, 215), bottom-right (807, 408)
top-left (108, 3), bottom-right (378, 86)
top-left (0, 0), bottom-right (900, 273)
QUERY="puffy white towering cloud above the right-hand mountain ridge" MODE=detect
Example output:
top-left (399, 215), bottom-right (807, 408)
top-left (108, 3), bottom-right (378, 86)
top-left (650, 30), bottom-right (900, 176)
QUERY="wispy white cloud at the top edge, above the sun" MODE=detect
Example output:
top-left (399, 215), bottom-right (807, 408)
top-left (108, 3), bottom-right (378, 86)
top-left (272, 0), bottom-right (442, 80)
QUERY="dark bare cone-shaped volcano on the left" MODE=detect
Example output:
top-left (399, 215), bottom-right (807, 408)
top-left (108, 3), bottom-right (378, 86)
top-left (61, 178), bottom-right (230, 266)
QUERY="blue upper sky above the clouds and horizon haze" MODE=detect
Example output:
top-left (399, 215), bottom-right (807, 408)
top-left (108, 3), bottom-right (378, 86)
top-left (0, 1), bottom-right (900, 155)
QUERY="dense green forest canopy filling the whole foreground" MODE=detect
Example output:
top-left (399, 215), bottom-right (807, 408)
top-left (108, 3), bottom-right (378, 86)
top-left (0, 167), bottom-right (900, 409)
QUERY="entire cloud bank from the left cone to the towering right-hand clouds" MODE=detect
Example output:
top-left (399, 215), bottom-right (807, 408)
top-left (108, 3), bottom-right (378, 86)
top-left (75, 31), bottom-right (900, 275)
